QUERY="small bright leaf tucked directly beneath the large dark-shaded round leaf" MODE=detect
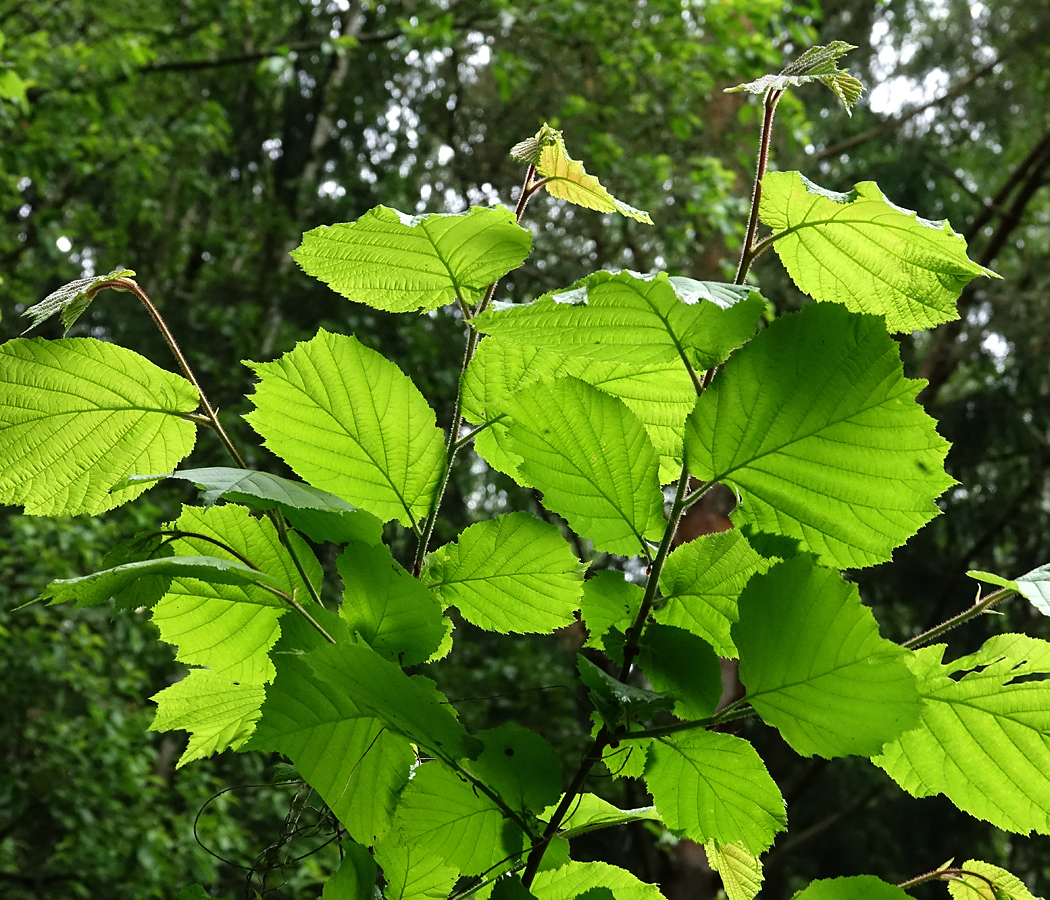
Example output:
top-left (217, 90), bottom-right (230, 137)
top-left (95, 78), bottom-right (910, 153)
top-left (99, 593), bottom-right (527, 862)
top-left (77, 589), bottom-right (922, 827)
top-left (653, 529), bottom-right (775, 658)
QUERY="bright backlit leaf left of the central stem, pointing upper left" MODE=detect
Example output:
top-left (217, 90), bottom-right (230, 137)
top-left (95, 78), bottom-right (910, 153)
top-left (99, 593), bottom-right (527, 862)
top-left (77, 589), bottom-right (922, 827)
top-left (245, 329), bottom-right (445, 527)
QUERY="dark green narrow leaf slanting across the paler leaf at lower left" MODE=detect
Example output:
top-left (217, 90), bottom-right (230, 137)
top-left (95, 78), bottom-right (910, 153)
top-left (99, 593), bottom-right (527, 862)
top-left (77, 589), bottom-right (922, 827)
top-left (310, 644), bottom-right (481, 759)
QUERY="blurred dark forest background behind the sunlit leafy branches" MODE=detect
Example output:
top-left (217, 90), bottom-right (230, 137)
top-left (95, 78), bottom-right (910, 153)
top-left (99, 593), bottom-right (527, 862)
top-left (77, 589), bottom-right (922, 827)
top-left (0, 0), bottom-right (1050, 898)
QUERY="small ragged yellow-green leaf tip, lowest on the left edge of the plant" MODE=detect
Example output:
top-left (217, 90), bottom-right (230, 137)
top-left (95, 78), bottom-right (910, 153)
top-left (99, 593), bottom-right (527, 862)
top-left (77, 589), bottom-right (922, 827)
top-left (149, 669), bottom-right (266, 769)
